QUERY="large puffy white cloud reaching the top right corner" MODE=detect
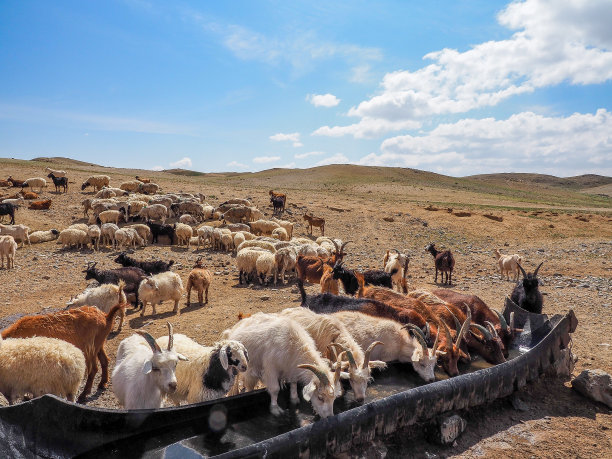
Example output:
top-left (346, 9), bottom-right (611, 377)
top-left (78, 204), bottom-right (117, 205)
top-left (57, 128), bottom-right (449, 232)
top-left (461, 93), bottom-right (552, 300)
top-left (315, 0), bottom-right (612, 137)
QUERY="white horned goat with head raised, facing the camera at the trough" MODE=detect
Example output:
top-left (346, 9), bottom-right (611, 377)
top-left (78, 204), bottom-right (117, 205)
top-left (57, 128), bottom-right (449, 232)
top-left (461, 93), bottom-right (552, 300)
top-left (112, 323), bottom-right (187, 410)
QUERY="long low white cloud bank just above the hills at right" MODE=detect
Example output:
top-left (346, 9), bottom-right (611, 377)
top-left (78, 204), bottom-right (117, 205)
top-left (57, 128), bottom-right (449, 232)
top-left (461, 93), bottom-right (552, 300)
top-left (358, 109), bottom-right (612, 175)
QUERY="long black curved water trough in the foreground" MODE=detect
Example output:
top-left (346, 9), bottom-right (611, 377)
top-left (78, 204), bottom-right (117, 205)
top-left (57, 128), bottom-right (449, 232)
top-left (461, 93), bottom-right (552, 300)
top-left (0, 300), bottom-right (577, 458)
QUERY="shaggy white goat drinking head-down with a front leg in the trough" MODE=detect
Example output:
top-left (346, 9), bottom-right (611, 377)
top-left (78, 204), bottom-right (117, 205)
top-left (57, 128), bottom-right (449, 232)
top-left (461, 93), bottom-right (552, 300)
top-left (222, 312), bottom-right (341, 418)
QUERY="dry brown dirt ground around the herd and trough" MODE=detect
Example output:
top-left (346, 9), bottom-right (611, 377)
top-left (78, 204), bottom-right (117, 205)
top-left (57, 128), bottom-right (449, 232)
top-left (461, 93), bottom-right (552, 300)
top-left (0, 160), bottom-right (612, 458)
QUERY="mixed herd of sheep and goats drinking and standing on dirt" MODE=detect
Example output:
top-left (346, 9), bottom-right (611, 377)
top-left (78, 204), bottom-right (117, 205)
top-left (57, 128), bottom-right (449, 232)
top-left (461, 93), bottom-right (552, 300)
top-left (0, 167), bottom-right (543, 417)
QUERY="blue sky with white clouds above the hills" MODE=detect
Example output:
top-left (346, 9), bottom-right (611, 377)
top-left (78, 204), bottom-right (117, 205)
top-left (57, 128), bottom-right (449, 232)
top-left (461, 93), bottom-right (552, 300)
top-left (0, 0), bottom-right (612, 176)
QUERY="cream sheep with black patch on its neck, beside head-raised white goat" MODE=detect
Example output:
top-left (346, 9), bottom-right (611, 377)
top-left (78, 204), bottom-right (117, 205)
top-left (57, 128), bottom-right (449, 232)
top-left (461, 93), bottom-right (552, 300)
top-left (157, 334), bottom-right (249, 406)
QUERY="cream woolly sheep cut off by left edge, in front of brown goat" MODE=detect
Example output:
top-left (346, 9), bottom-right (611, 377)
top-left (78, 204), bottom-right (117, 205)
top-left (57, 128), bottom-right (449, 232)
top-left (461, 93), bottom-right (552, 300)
top-left (0, 336), bottom-right (85, 405)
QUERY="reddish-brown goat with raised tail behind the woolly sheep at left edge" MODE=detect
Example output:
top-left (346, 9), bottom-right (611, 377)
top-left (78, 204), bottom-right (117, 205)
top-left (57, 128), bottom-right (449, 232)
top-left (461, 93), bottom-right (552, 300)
top-left (2, 302), bottom-right (127, 403)
